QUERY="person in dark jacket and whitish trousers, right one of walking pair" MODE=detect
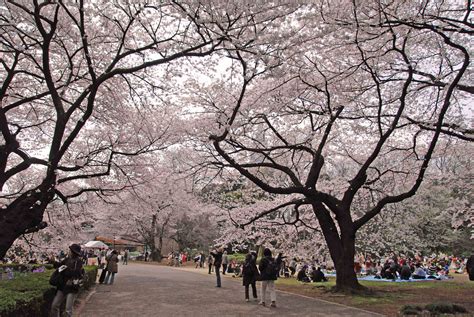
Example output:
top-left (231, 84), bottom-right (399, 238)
top-left (258, 248), bottom-right (279, 307)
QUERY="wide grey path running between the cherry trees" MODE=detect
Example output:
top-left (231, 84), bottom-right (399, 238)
top-left (75, 263), bottom-right (381, 317)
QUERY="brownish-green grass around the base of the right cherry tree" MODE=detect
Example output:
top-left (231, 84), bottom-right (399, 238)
top-left (276, 274), bottom-right (474, 316)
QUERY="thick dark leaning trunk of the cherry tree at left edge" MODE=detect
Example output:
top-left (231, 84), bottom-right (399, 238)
top-left (0, 190), bottom-right (53, 259)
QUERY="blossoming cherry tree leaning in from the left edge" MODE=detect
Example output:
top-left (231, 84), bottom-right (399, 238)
top-left (0, 0), bottom-right (296, 257)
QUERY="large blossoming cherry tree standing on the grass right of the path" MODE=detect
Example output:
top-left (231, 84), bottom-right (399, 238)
top-left (201, 1), bottom-right (473, 290)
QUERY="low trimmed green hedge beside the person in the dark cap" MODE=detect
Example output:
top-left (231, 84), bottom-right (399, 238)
top-left (0, 266), bottom-right (97, 317)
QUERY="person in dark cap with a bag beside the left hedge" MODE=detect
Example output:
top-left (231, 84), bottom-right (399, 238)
top-left (51, 243), bottom-right (84, 317)
